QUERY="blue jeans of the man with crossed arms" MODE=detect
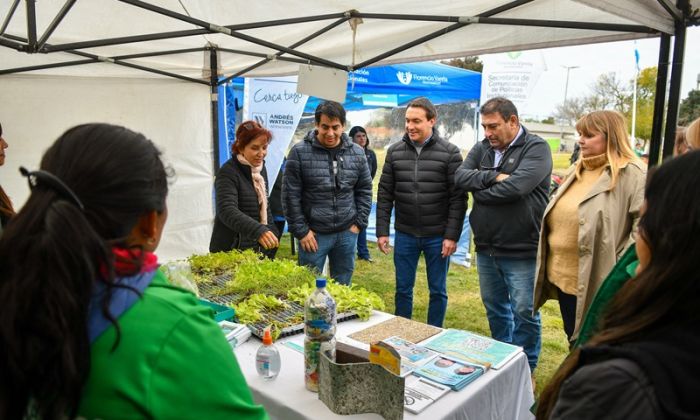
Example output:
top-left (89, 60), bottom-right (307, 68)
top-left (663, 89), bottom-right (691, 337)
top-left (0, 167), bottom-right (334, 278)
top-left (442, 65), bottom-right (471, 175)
top-left (476, 252), bottom-right (542, 372)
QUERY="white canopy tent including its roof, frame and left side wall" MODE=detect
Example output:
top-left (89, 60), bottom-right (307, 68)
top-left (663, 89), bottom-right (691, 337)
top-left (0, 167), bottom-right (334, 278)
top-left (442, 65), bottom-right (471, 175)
top-left (0, 0), bottom-right (700, 259)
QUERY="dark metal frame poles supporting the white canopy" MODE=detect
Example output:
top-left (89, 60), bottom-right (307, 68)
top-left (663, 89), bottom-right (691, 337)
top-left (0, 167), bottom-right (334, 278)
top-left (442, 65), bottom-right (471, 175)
top-left (0, 0), bottom-right (699, 169)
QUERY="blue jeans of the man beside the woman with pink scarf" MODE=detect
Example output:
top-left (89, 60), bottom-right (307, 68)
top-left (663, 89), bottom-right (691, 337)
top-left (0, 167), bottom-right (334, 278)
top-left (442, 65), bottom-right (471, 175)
top-left (299, 230), bottom-right (357, 286)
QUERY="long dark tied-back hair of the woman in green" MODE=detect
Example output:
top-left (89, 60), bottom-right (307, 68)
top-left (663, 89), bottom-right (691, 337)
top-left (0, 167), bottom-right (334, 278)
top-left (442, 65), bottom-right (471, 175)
top-left (0, 124), bottom-right (168, 419)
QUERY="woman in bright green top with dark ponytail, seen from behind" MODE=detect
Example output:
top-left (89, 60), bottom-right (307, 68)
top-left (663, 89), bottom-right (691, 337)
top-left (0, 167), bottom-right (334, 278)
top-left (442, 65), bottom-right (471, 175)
top-left (0, 124), bottom-right (267, 419)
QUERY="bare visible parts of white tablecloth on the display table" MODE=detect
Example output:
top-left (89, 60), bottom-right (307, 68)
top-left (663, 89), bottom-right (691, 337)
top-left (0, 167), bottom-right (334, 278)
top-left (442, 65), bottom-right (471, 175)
top-left (235, 311), bottom-right (534, 420)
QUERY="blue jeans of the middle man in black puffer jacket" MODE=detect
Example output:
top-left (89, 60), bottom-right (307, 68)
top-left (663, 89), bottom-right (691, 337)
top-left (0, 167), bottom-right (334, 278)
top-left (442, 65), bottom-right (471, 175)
top-left (394, 231), bottom-right (450, 327)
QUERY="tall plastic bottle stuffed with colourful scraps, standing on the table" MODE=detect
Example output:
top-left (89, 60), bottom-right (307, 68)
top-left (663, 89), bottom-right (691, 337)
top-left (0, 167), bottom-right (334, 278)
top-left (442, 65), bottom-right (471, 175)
top-left (304, 278), bottom-right (337, 392)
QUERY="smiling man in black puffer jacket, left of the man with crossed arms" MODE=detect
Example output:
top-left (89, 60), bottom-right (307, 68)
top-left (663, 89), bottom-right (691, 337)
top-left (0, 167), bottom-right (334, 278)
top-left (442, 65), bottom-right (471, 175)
top-left (377, 98), bottom-right (466, 327)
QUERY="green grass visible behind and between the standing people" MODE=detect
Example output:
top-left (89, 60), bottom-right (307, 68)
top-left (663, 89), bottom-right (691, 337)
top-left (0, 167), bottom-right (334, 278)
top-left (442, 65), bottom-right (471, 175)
top-left (278, 149), bottom-right (569, 391)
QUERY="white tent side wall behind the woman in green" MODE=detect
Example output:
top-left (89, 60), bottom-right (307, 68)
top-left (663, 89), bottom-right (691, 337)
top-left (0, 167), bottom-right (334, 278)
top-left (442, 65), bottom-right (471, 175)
top-left (0, 76), bottom-right (213, 261)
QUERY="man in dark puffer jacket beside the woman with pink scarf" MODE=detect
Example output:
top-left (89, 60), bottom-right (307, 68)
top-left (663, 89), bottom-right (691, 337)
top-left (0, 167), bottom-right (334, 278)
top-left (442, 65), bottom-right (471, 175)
top-left (282, 101), bottom-right (372, 285)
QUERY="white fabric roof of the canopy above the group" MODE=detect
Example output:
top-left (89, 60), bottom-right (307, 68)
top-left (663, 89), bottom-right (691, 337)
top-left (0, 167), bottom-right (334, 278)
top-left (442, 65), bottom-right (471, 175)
top-left (0, 0), bottom-right (700, 78)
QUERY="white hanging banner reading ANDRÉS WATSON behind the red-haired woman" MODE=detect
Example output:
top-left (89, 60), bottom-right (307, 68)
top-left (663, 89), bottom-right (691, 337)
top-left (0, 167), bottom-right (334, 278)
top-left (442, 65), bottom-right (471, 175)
top-left (243, 76), bottom-right (309, 187)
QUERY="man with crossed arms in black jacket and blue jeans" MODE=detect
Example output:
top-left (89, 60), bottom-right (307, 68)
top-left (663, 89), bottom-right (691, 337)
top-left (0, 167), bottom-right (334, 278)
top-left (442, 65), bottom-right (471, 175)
top-left (455, 98), bottom-right (552, 371)
